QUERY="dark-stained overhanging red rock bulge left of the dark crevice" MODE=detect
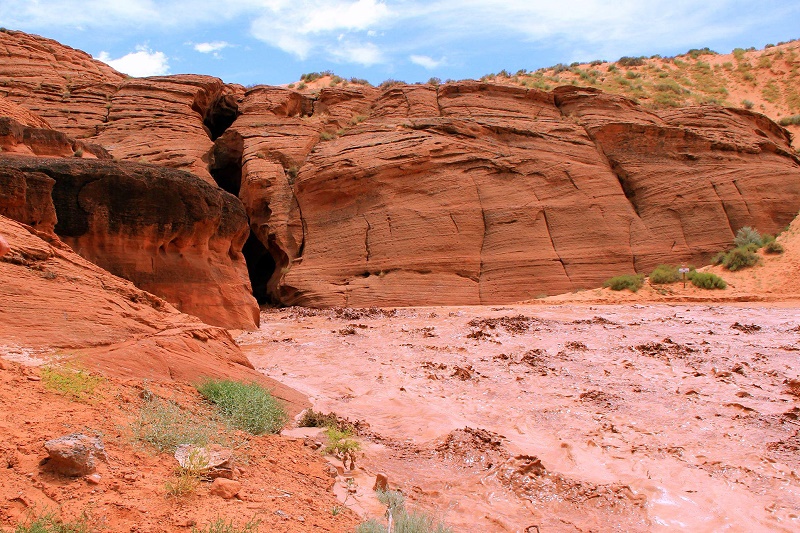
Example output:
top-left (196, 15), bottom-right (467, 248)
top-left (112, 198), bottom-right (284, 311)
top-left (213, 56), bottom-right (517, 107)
top-left (0, 157), bottom-right (258, 329)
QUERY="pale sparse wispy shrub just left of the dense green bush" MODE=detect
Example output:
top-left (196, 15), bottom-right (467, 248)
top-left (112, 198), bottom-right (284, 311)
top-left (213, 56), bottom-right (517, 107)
top-left (131, 391), bottom-right (219, 453)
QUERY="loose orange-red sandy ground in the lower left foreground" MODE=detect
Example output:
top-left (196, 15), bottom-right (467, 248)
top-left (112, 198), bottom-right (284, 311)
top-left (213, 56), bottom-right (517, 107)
top-left (0, 366), bottom-right (358, 533)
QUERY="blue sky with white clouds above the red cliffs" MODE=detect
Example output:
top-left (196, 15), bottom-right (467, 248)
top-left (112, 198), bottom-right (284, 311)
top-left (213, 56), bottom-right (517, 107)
top-left (0, 0), bottom-right (800, 85)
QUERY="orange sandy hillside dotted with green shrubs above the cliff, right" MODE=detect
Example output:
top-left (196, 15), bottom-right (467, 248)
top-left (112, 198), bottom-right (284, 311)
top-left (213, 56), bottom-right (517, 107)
top-left (490, 40), bottom-right (800, 126)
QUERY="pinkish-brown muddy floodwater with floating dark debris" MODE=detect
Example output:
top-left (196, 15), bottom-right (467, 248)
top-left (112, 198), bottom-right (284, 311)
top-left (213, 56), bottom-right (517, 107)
top-left (237, 305), bottom-right (800, 533)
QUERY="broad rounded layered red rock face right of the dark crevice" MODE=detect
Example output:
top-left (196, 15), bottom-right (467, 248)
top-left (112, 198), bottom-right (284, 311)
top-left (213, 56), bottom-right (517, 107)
top-left (256, 82), bottom-right (800, 306)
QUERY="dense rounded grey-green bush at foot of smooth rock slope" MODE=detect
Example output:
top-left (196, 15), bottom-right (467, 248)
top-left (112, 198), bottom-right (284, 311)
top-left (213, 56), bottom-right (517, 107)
top-left (197, 379), bottom-right (289, 435)
